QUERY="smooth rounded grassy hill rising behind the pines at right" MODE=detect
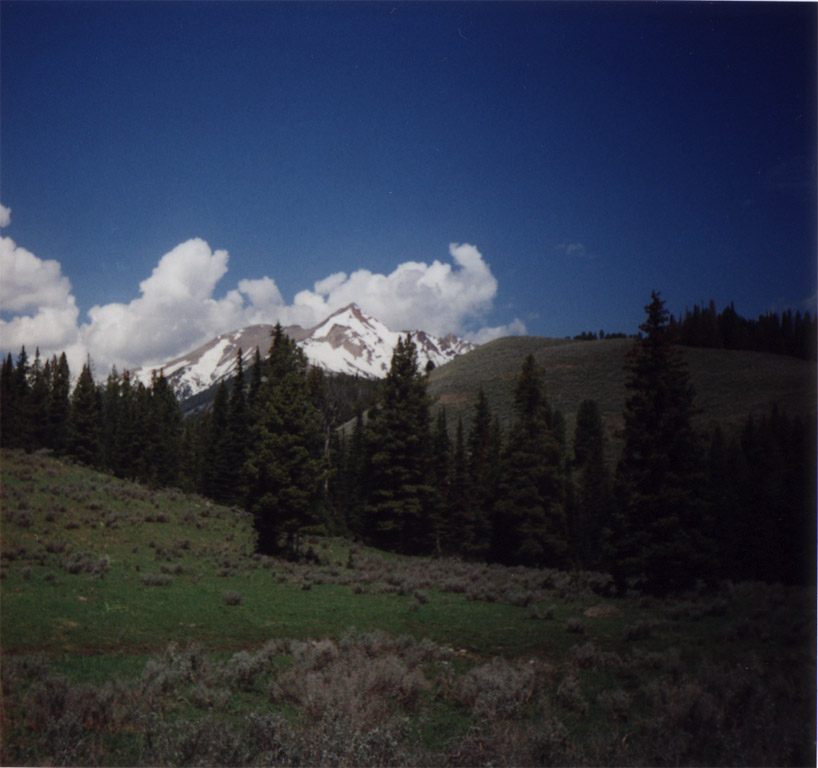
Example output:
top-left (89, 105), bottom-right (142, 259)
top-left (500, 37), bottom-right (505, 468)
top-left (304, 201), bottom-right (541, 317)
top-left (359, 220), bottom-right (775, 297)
top-left (429, 336), bottom-right (816, 450)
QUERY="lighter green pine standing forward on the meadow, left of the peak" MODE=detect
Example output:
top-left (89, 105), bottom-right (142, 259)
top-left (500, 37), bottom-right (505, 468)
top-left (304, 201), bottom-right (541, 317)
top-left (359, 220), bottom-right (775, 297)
top-left (243, 324), bottom-right (324, 555)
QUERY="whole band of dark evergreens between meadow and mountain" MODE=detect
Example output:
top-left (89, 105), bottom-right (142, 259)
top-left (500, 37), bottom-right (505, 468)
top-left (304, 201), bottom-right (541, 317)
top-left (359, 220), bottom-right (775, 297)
top-left (0, 294), bottom-right (815, 592)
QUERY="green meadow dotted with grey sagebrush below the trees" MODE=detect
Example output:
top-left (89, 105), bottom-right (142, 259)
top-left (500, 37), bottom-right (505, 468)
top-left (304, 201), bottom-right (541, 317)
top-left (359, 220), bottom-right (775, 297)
top-left (0, 452), bottom-right (816, 765)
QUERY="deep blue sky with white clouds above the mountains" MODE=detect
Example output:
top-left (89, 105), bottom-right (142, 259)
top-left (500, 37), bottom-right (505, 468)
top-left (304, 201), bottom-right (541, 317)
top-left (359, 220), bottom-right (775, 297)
top-left (0, 0), bottom-right (816, 369)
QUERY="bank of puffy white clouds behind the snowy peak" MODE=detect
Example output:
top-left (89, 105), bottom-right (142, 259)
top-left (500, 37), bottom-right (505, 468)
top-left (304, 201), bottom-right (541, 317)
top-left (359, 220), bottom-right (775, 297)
top-left (0, 238), bottom-right (525, 375)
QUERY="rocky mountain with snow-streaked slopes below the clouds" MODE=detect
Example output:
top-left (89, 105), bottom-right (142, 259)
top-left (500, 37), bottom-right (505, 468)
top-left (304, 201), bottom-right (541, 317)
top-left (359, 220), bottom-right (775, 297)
top-left (132, 304), bottom-right (475, 400)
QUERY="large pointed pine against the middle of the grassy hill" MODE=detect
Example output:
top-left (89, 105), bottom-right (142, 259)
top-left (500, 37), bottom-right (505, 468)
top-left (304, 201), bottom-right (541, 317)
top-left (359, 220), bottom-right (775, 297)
top-left (494, 355), bottom-right (568, 567)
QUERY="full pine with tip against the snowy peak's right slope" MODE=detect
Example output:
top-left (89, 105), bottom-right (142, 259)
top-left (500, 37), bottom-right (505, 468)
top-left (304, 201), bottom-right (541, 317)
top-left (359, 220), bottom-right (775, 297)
top-left (366, 335), bottom-right (435, 553)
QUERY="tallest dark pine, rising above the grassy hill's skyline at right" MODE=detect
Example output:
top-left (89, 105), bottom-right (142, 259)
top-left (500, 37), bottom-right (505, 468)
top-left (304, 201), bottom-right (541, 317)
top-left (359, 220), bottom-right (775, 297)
top-left (614, 292), bottom-right (714, 592)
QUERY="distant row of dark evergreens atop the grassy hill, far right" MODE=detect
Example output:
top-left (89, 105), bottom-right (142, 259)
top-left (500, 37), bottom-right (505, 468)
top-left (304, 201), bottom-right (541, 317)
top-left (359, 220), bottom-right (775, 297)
top-left (669, 299), bottom-right (818, 360)
